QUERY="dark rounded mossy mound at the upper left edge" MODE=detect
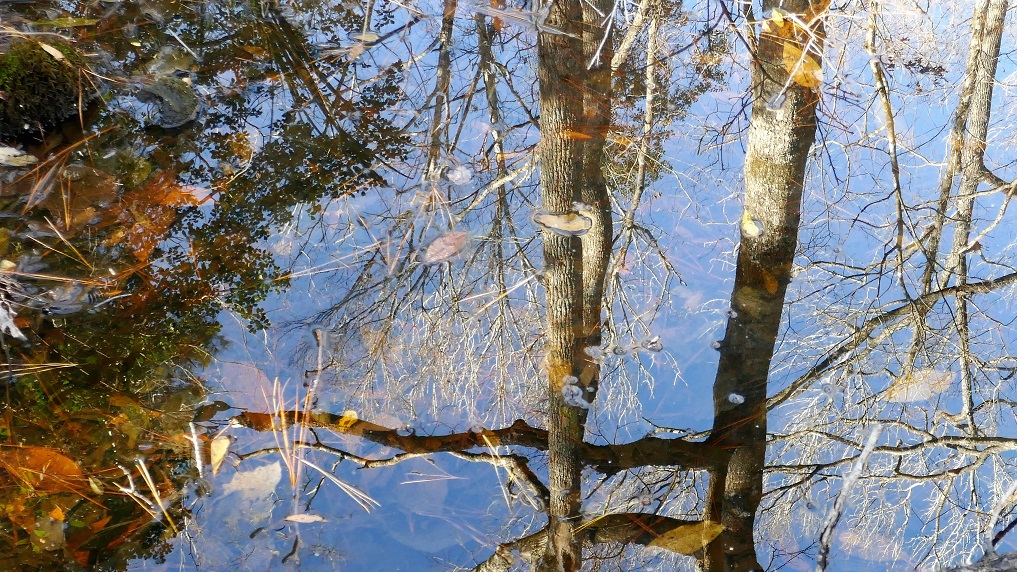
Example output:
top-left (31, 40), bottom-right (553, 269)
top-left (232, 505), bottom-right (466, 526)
top-left (0, 41), bottom-right (83, 138)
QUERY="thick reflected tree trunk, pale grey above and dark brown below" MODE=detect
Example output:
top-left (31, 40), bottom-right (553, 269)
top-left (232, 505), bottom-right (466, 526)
top-left (703, 0), bottom-right (822, 571)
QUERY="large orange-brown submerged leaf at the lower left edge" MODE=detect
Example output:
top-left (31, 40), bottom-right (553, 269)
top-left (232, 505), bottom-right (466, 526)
top-left (0, 447), bottom-right (87, 493)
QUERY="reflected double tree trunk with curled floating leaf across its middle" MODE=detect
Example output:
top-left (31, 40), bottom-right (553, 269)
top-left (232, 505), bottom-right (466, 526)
top-left (537, 0), bottom-right (612, 570)
